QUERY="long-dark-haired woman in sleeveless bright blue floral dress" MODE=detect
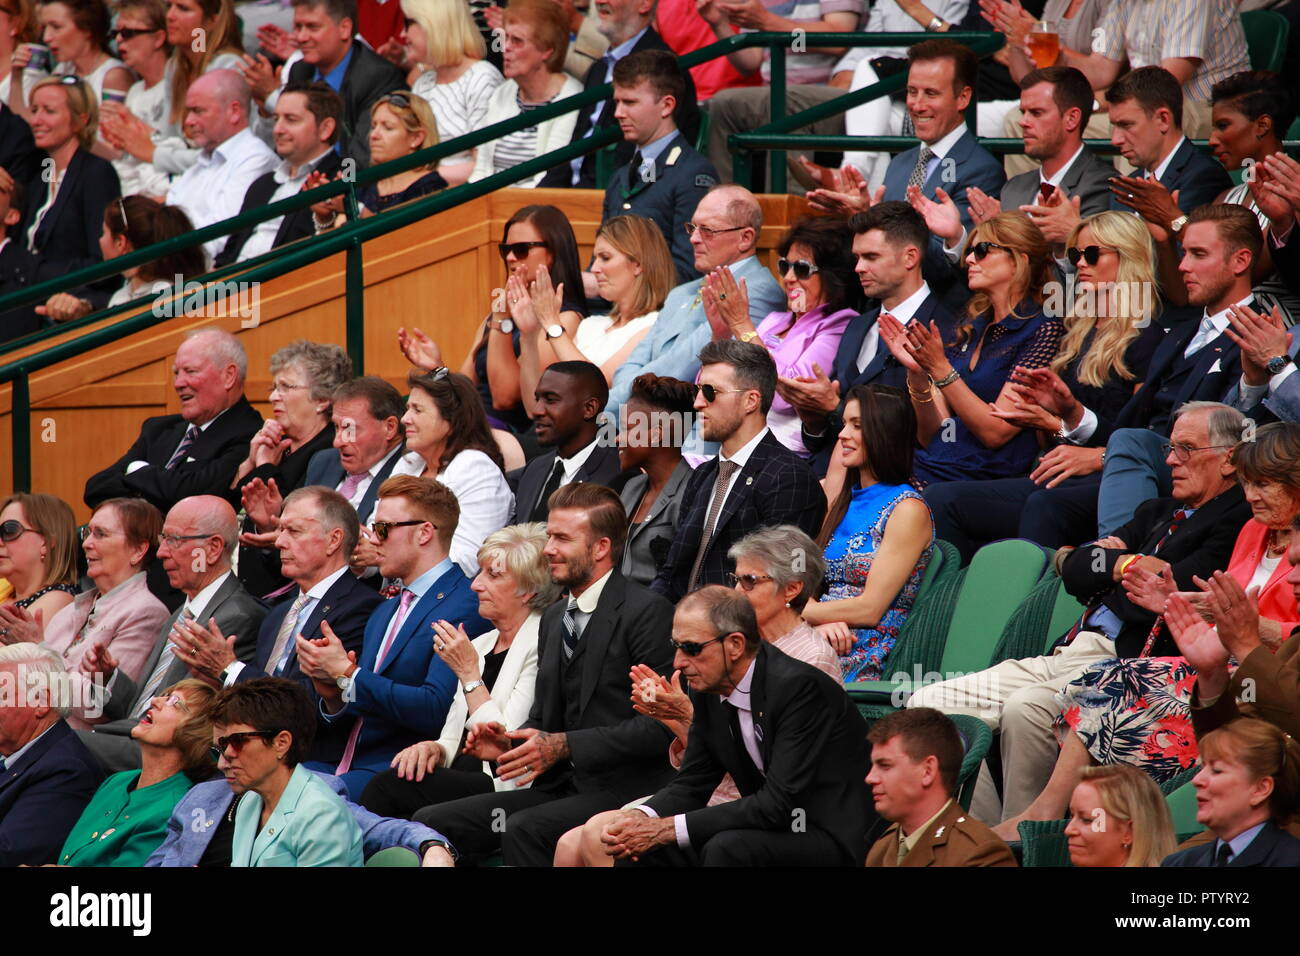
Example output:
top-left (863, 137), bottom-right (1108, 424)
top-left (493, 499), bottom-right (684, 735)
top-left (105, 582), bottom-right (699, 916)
top-left (803, 385), bottom-right (935, 683)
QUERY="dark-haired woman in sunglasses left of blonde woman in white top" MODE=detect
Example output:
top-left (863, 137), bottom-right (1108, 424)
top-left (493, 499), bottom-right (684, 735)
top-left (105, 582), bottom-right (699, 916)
top-left (398, 208), bottom-right (586, 434)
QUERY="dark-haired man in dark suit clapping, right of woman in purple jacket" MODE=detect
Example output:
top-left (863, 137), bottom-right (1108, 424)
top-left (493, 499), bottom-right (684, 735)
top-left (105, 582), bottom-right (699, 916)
top-left (776, 202), bottom-right (954, 476)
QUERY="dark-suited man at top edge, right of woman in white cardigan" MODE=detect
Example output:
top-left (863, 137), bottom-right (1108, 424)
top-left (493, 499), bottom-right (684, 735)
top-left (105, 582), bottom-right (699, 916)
top-left (538, 0), bottom-right (699, 191)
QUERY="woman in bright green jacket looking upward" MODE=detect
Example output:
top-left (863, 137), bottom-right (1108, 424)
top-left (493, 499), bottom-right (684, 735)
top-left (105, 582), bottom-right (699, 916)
top-left (59, 679), bottom-right (217, 866)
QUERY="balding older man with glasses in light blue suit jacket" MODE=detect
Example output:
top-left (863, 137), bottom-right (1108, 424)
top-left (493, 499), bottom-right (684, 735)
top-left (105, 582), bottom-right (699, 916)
top-left (605, 185), bottom-right (787, 416)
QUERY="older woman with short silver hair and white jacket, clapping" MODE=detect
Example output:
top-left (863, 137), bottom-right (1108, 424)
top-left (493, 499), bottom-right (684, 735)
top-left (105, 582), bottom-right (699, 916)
top-left (360, 522), bottom-right (559, 819)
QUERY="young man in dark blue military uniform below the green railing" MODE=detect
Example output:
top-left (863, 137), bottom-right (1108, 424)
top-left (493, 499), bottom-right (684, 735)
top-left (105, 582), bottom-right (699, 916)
top-left (602, 49), bottom-right (718, 282)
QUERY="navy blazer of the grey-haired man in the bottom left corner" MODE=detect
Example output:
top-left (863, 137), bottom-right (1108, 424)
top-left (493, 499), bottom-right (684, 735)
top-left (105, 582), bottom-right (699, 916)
top-left (0, 721), bottom-right (104, 866)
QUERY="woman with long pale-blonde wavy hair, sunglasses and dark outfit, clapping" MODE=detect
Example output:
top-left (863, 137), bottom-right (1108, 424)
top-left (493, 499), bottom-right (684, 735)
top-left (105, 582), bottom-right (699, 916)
top-left (926, 212), bottom-right (1165, 558)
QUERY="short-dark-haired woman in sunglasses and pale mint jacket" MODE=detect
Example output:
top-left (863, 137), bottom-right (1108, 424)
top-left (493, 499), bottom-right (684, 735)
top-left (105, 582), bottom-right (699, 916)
top-left (212, 678), bottom-right (361, 866)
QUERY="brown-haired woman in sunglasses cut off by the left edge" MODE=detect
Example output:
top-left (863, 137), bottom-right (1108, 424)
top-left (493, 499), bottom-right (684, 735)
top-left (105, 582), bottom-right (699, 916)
top-left (0, 494), bottom-right (77, 632)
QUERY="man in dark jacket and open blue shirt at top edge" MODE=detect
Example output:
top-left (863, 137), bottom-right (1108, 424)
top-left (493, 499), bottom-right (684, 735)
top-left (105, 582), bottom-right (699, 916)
top-left (279, 0), bottom-right (407, 166)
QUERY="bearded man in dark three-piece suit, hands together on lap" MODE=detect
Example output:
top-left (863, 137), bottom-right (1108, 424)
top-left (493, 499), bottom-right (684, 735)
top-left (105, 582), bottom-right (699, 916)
top-left (415, 483), bottom-right (672, 866)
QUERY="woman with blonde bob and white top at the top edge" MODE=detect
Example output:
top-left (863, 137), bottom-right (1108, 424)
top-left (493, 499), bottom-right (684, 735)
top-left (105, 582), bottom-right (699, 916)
top-left (402, 0), bottom-right (506, 186)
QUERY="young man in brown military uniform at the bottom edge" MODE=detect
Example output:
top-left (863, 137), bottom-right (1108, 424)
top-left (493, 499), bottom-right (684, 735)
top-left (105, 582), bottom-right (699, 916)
top-left (867, 708), bottom-right (1015, 866)
